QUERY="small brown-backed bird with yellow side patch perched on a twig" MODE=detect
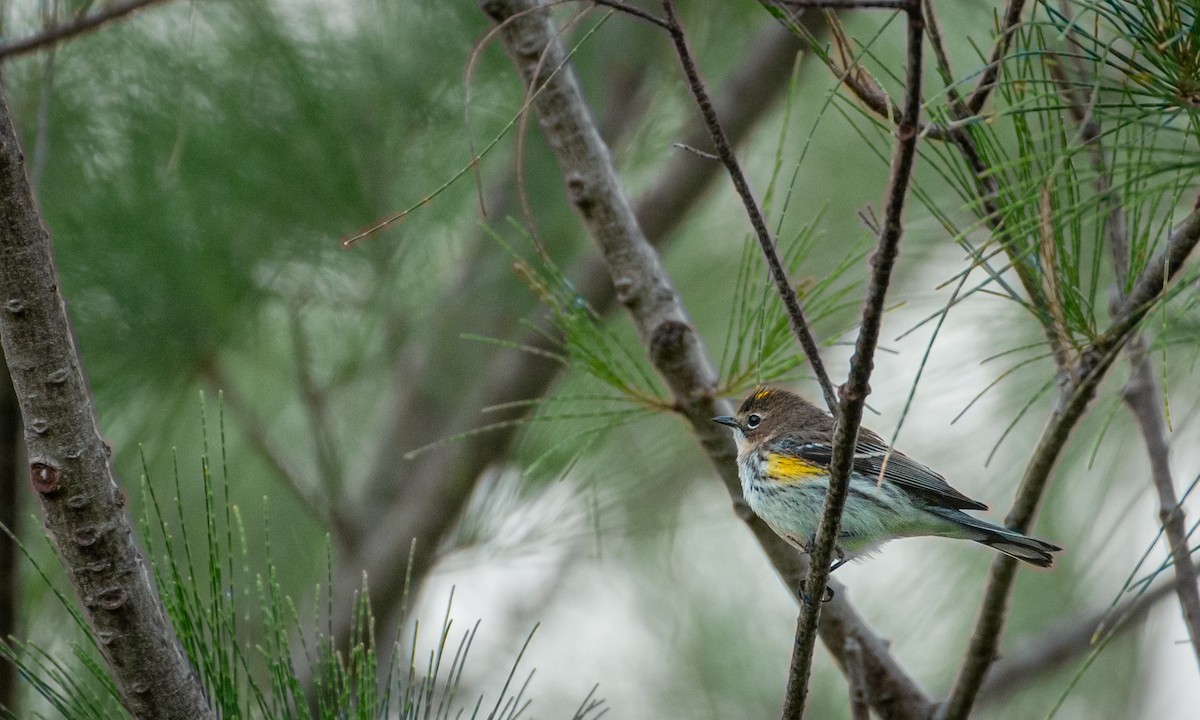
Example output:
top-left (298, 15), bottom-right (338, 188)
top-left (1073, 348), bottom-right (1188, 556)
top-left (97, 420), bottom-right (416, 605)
top-left (713, 388), bottom-right (1062, 570)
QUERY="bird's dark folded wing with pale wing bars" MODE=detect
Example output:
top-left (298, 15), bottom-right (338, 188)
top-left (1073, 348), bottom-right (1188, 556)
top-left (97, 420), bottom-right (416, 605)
top-left (781, 430), bottom-right (988, 510)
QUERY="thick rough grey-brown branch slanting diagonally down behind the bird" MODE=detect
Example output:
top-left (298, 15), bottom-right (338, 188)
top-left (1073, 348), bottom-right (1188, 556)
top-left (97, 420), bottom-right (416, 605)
top-left (472, 0), bottom-right (931, 718)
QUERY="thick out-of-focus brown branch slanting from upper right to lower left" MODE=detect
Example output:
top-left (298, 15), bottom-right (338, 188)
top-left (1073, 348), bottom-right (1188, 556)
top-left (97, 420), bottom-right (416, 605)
top-left (335, 15), bottom-right (820, 648)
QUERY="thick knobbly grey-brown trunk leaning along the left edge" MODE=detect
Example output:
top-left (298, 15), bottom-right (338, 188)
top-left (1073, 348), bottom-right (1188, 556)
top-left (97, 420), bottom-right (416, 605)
top-left (0, 95), bottom-right (212, 719)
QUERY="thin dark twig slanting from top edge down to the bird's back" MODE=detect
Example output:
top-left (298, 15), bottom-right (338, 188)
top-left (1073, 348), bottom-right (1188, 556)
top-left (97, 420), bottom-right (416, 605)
top-left (662, 0), bottom-right (838, 414)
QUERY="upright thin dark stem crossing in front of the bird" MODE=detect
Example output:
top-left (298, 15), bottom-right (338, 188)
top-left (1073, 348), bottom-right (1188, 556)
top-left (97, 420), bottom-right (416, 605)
top-left (784, 0), bottom-right (925, 720)
